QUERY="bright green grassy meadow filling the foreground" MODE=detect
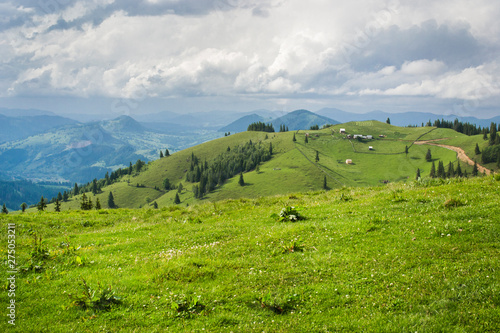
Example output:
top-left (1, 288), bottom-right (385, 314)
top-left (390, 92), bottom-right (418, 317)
top-left (0, 177), bottom-right (500, 332)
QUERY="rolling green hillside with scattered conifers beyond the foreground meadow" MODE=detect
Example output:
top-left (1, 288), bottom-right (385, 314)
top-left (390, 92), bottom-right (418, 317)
top-left (30, 121), bottom-right (496, 210)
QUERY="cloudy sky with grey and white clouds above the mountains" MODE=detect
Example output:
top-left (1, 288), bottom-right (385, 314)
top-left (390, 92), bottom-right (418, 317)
top-left (0, 0), bottom-right (500, 118)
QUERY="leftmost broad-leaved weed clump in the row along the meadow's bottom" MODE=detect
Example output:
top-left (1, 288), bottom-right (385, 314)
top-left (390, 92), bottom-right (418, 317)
top-left (68, 278), bottom-right (121, 311)
